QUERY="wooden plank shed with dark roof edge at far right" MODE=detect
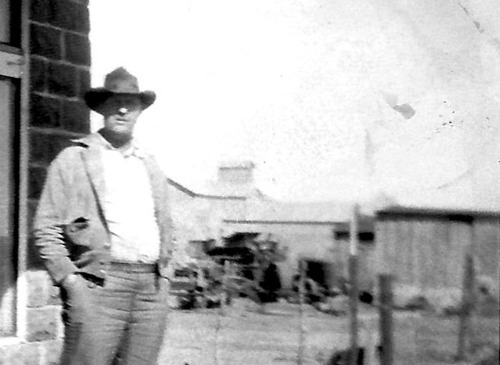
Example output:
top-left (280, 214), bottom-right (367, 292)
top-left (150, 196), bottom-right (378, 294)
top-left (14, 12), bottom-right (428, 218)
top-left (375, 206), bottom-right (500, 293)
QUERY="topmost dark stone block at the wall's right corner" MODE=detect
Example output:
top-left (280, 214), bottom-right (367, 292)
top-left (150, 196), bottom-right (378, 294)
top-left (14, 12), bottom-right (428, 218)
top-left (49, 0), bottom-right (90, 34)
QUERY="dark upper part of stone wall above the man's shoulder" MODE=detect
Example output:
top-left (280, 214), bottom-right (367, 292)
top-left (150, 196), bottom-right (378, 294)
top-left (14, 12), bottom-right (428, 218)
top-left (29, 0), bottom-right (90, 210)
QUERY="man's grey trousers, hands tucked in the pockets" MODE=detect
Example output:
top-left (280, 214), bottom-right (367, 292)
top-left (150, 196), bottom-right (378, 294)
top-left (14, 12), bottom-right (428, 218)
top-left (60, 269), bottom-right (168, 365)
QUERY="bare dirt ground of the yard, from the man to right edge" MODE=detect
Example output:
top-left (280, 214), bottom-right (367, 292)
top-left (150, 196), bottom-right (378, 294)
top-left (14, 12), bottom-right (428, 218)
top-left (159, 302), bottom-right (498, 365)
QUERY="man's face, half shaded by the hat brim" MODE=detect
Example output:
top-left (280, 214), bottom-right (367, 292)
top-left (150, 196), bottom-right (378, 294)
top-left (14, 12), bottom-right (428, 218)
top-left (101, 95), bottom-right (142, 138)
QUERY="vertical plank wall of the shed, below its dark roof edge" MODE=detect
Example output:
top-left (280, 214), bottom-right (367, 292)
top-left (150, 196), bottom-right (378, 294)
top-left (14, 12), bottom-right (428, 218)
top-left (375, 216), bottom-right (488, 289)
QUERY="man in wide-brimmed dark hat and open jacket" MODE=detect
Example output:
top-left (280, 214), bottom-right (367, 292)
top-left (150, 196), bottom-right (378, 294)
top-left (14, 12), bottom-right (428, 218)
top-left (34, 68), bottom-right (173, 365)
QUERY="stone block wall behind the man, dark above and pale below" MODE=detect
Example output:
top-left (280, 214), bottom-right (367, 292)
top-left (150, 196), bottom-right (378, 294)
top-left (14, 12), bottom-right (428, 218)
top-left (0, 0), bottom-right (91, 365)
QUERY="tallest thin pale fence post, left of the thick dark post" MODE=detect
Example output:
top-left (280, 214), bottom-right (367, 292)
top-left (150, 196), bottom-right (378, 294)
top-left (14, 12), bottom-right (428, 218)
top-left (349, 204), bottom-right (359, 365)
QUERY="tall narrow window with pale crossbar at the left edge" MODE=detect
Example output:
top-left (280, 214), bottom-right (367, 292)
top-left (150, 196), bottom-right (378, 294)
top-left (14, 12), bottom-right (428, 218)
top-left (0, 0), bottom-right (22, 337)
